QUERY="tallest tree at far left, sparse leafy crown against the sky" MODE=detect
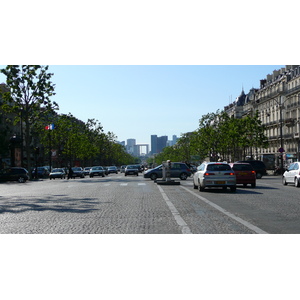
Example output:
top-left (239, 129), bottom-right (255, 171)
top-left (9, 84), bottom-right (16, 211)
top-left (0, 65), bottom-right (58, 176)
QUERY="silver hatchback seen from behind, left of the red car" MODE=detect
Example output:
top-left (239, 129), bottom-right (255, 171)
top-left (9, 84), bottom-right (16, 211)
top-left (193, 162), bottom-right (236, 192)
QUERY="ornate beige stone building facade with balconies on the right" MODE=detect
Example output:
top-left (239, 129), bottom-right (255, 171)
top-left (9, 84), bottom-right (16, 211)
top-left (224, 65), bottom-right (300, 167)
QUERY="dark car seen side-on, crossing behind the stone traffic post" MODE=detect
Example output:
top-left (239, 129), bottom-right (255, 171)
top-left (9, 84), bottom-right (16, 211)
top-left (144, 162), bottom-right (192, 180)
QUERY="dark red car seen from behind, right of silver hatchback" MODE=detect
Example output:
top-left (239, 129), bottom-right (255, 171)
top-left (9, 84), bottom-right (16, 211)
top-left (229, 163), bottom-right (256, 188)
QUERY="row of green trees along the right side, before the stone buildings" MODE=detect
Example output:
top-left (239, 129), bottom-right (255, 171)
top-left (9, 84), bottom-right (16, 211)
top-left (149, 111), bottom-right (268, 163)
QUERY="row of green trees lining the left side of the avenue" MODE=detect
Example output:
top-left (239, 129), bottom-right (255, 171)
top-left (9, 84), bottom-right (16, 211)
top-left (0, 65), bottom-right (135, 176)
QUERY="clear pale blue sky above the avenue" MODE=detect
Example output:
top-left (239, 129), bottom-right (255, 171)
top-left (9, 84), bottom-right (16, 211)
top-left (0, 65), bottom-right (284, 144)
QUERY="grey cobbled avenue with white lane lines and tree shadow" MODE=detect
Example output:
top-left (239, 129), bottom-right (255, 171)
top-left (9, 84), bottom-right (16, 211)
top-left (0, 173), bottom-right (300, 234)
